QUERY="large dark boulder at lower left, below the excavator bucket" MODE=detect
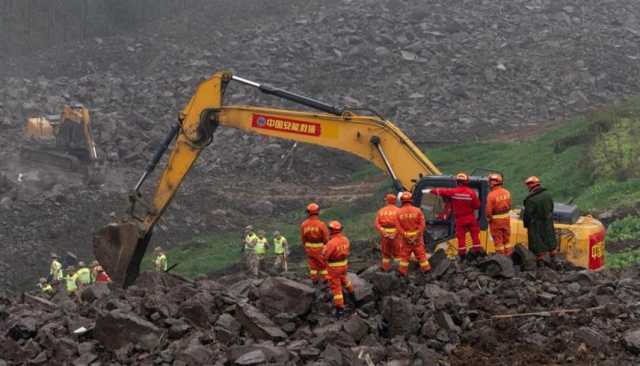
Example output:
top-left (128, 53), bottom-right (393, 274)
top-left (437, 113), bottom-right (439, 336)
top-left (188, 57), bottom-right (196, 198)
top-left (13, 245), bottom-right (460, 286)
top-left (94, 309), bottom-right (163, 351)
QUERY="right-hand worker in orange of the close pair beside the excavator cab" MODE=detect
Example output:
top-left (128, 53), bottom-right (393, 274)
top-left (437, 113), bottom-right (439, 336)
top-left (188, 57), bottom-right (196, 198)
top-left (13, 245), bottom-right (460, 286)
top-left (398, 192), bottom-right (431, 276)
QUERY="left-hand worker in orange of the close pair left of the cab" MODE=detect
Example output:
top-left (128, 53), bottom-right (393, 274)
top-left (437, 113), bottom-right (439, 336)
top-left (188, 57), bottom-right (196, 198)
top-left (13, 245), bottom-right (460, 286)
top-left (375, 194), bottom-right (400, 272)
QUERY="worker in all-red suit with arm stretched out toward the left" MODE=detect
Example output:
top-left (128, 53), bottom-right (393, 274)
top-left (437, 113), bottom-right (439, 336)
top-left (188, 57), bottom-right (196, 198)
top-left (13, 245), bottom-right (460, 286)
top-left (426, 173), bottom-right (483, 260)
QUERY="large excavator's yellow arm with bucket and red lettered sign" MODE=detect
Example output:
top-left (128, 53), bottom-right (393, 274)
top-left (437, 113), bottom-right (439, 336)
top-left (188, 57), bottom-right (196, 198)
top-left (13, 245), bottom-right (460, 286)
top-left (94, 71), bottom-right (440, 286)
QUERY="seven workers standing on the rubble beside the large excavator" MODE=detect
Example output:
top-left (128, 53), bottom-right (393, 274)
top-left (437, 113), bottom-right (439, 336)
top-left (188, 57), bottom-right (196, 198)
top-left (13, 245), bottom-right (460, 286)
top-left (300, 173), bottom-right (557, 317)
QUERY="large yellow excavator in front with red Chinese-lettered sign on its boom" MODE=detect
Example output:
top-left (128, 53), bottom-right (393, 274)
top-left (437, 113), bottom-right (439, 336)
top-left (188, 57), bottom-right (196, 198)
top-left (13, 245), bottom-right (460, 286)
top-left (94, 71), bottom-right (604, 287)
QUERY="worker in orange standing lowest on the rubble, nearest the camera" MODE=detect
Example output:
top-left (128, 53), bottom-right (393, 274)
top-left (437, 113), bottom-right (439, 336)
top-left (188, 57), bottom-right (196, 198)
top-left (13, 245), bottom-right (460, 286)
top-left (322, 221), bottom-right (353, 318)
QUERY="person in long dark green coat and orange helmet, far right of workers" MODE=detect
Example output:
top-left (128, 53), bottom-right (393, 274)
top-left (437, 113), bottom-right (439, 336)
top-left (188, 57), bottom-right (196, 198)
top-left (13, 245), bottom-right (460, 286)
top-left (522, 176), bottom-right (558, 267)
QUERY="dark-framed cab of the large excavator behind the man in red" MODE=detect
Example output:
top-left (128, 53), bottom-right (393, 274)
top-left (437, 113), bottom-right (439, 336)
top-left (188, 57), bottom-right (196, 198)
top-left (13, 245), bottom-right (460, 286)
top-left (413, 175), bottom-right (489, 252)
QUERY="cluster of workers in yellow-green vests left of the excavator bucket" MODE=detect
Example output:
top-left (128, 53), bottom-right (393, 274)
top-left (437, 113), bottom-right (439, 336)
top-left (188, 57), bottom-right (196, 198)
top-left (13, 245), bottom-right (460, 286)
top-left (38, 253), bottom-right (111, 297)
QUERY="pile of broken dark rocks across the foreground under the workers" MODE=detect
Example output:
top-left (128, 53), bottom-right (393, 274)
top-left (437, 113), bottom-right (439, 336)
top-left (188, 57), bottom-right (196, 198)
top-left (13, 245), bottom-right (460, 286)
top-left (0, 250), bottom-right (640, 365)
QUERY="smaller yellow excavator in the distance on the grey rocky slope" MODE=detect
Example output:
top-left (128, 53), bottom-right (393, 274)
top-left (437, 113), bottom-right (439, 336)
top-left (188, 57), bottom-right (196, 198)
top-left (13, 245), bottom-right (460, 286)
top-left (20, 104), bottom-right (98, 171)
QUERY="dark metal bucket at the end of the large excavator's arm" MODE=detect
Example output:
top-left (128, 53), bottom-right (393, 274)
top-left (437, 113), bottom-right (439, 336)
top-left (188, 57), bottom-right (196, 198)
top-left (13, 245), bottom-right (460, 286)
top-left (93, 222), bottom-right (151, 288)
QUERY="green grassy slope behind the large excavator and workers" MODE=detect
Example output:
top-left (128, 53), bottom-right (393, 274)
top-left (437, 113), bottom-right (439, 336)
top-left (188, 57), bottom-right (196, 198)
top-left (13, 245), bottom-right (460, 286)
top-left (155, 99), bottom-right (640, 276)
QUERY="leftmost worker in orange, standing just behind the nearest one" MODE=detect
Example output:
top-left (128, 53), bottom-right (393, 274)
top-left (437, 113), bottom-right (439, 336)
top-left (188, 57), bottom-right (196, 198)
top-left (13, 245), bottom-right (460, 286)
top-left (300, 203), bottom-right (329, 285)
